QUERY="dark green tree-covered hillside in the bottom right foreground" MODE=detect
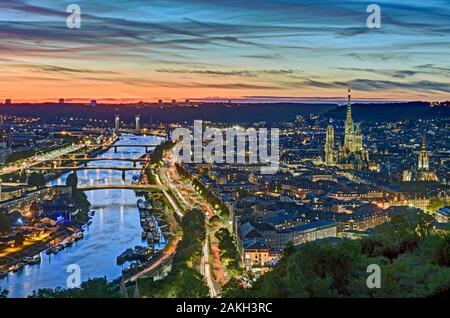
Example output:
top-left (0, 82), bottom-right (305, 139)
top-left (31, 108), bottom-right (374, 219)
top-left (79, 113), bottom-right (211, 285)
top-left (223, 213), bottom-right (450, 298)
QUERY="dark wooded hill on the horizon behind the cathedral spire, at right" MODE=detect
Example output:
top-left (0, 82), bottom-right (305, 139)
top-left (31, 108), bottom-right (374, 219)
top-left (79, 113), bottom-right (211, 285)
top-left (324, 102), bottom-right (450, 122)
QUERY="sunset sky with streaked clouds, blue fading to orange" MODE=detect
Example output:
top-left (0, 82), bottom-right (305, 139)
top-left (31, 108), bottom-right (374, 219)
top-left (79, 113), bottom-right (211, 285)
top-left (0, 0), bottom-right (450, 102)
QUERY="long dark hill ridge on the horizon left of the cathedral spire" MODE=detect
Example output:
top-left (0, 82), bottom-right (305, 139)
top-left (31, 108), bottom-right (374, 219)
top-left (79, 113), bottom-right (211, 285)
top-left (0, 103), bottom-right (337, 123)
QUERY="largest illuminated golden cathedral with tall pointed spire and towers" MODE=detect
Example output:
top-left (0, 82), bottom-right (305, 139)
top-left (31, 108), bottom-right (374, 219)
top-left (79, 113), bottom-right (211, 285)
top-left (325, 88), bottom-right (373, 170)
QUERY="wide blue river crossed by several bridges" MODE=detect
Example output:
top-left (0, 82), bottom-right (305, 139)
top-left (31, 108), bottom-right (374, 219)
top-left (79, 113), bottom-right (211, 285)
top-left (0, 135), bottom-right (165, 297)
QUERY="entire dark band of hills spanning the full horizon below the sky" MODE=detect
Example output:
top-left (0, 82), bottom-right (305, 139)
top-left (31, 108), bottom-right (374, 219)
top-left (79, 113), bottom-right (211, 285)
top-left (0, 102), bottom-right (450, 124)
